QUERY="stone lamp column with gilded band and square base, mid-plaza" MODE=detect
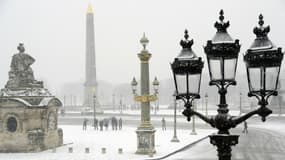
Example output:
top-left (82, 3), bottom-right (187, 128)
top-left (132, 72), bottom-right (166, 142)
top-left (135, 34), bottom-right (157, 155)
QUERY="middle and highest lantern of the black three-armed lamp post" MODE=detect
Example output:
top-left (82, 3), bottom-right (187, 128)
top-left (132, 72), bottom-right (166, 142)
top-left (204, 10), bottom-right (240, 85)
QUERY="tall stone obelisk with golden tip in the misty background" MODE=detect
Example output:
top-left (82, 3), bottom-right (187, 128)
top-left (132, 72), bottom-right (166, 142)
top-left (83, 3), bottom-right (102, 112)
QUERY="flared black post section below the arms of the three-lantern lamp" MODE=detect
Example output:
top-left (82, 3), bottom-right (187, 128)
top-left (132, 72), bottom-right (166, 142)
top-left (209, 134), bottom-right (239, 160)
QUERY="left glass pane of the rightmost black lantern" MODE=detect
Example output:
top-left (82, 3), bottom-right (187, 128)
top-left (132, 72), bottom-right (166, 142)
top-left (248, 68), bottom-right (263, 91)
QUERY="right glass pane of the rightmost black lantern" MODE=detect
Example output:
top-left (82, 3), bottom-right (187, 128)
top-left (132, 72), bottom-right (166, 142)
top-left (265, 66), bottom-right (280, 90)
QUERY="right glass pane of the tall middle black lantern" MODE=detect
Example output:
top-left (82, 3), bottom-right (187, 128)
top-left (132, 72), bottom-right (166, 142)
top-left (224, 58), bottom-right (237, 79)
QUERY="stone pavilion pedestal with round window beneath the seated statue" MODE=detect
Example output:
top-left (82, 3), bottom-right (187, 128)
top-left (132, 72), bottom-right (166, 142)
top-left (0, 88), bottom-right (63, 152)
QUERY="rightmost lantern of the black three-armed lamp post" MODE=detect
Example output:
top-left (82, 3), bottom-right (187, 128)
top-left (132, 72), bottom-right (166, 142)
top-left (244, 14), bottom-right (283, 121)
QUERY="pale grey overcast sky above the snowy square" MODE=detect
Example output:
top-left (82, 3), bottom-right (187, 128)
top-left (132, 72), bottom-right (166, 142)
top-left (0, 0), bottom-right (285, 92)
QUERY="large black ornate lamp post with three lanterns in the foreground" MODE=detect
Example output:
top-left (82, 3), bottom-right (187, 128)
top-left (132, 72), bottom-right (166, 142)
top-left (171, 10), bottom-right (283, 160)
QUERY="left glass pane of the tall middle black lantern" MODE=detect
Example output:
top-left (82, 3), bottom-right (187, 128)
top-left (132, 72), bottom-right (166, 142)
top-left (209, 59), bottom-right (222, 80)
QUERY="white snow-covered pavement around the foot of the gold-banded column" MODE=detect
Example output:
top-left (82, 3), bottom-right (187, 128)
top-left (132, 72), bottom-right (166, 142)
top-left (0, 125), bottom-right (215, 160)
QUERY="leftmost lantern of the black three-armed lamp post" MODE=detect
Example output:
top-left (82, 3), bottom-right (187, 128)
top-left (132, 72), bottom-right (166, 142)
top-left (171, 30), bottom-right (204, 121)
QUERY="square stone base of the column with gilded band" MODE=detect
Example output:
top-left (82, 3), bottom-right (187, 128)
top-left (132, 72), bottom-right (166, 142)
top-left (136, 127), bottom-right (156, 155)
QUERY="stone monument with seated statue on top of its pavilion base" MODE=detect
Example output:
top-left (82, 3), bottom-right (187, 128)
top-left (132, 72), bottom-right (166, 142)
top-left (0, 43), bottom-right (63, 152)
